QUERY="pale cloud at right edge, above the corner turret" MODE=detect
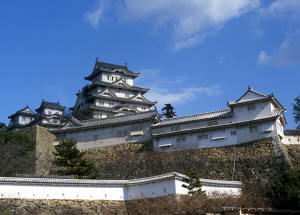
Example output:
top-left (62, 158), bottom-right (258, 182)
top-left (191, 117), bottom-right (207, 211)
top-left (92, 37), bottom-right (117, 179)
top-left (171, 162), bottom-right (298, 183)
top-left (257, 35), bottom-right (300, 66)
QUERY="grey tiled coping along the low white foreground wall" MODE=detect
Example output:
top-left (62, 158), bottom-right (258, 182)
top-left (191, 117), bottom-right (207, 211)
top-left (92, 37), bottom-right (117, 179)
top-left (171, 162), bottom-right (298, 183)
top-left (0, 172), bottom-right (243, 188)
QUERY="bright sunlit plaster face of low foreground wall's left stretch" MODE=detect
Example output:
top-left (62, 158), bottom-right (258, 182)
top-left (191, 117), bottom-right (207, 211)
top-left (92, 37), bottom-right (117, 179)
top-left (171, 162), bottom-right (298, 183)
top-left (0, 184), bottom-right (124, 200)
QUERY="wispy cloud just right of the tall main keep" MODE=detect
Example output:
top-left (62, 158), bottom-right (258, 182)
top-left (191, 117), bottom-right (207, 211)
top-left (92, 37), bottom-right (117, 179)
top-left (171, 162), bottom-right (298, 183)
top-left (137, 70), bottom-right (222, 108)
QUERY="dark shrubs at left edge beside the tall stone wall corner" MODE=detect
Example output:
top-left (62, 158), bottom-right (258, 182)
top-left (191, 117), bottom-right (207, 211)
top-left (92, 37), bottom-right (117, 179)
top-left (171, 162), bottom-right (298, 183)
top-left (0, 123), bottom-right (35, 176)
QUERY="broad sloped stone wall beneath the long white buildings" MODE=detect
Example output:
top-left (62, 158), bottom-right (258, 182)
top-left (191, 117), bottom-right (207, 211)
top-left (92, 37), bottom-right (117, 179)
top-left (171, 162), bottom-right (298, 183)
top-left (87, 139), bottom-right (288, 183)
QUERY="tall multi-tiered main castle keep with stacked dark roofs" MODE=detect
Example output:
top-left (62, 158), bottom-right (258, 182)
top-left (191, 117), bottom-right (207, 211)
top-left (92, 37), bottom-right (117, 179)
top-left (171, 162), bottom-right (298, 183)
top-left (73, 59), bottom-right (156, 119)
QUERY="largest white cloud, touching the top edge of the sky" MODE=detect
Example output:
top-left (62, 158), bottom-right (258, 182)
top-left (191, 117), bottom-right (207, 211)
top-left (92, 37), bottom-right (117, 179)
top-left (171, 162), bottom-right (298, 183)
top-left (124, 0), bottom-right (259, 51)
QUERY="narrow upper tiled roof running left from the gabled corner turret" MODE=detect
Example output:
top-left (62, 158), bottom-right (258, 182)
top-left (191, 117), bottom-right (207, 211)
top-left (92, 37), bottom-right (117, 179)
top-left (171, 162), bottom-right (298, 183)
top-left (152, 110), bottom-right (232, 128)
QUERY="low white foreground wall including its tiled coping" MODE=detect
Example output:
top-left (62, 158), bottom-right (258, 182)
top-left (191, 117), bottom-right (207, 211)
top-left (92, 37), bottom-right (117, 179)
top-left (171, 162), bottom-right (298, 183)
top-left (0, 172), bottom-right (243, 201)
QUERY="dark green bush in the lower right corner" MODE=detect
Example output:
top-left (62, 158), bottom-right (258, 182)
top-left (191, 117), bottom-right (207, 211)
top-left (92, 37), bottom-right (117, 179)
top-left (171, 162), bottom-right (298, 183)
top-left (267, 170), bottom-right (300, 210)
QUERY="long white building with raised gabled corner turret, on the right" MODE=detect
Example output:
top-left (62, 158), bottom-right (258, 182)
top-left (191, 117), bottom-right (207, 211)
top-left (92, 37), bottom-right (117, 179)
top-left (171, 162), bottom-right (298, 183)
top-left (152, 87), bottom-right (286, 152)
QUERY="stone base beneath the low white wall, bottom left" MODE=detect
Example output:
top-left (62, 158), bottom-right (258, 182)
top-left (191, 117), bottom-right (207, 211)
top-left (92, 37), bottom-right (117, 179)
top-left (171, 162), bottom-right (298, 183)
top-left (0, 199), bottom-right (127, 215)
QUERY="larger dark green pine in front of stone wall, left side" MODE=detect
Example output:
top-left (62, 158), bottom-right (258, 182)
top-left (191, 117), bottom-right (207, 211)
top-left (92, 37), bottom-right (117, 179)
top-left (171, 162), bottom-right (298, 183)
top-left (54, 140), bottom-right (95, 177)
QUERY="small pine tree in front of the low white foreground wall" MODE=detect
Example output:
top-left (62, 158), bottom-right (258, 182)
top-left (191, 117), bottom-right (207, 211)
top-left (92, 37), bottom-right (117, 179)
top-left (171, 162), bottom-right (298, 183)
top-left (182, 172), bottom-right (205, 195)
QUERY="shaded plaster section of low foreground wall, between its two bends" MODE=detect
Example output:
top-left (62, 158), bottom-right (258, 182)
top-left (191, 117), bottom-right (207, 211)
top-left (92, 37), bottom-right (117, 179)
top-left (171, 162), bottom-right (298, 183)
top-left (127, 179), bottom-right (176, 200)
